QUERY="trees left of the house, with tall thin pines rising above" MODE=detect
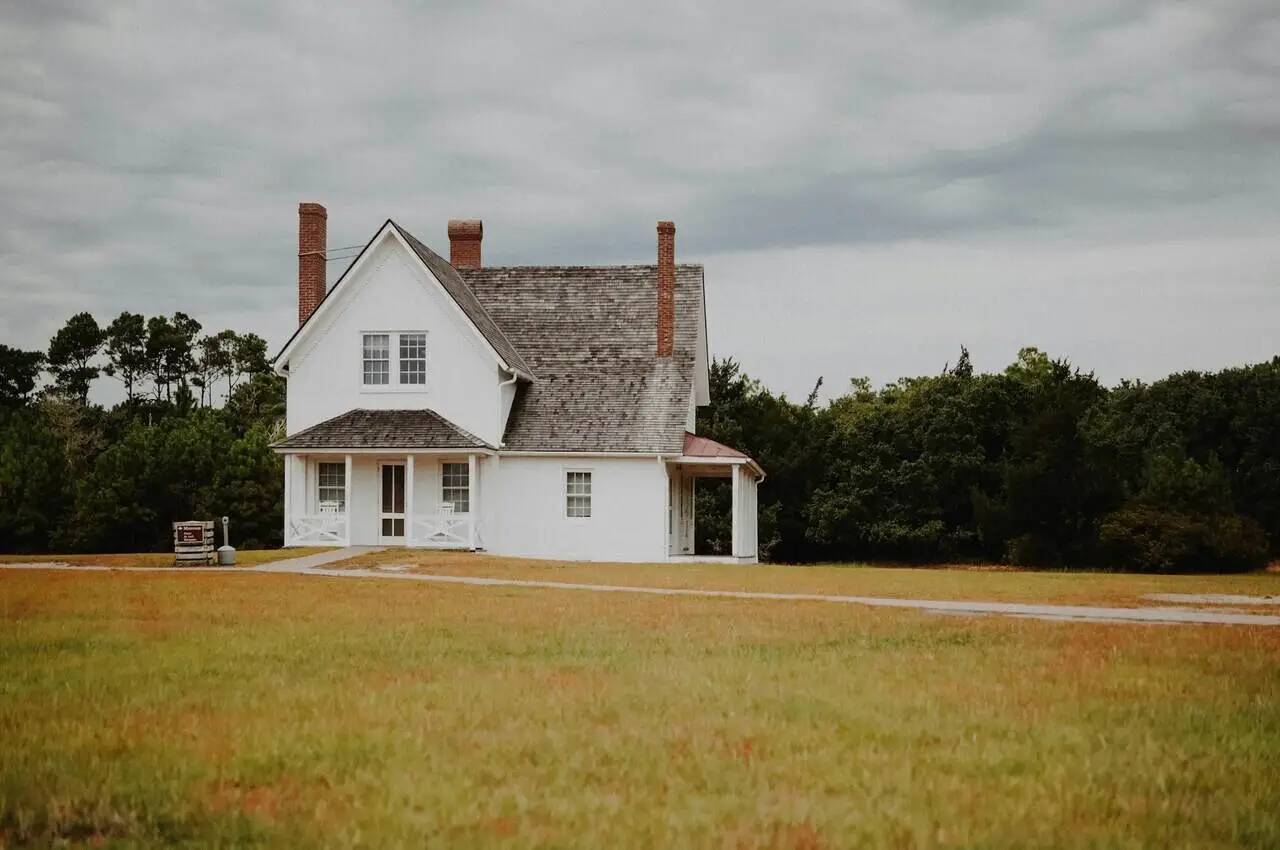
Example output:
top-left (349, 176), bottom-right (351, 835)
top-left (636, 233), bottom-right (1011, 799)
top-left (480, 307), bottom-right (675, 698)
top-left (0, 312), bottom-right (284, 553)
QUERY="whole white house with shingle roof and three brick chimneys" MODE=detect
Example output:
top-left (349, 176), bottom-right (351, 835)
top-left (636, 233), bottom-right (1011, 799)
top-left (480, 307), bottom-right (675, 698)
top-left (274, 204), bottom-right (764, 562)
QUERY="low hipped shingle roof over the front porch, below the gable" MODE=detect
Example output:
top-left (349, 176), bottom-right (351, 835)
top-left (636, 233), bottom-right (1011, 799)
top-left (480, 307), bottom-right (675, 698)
top-left (273, 410), bottom-right (494, 449)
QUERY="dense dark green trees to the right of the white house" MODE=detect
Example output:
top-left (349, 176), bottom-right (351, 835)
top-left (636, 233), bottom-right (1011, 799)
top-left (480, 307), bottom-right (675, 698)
top-left (698, 348), bottom-right (1280, 572)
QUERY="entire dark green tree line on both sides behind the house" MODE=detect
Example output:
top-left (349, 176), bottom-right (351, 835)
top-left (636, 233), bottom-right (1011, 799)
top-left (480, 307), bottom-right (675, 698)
top-left (0, 312), bottom-right (1280, 571)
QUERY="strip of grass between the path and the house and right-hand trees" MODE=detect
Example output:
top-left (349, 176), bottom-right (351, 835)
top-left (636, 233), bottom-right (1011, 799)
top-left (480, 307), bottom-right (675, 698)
top-left (332, 549), bottom-right (1280, 607)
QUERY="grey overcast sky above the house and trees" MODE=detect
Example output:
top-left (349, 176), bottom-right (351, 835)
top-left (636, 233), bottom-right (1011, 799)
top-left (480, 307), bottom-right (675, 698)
top-left (0, 0), bottom-right (1280, 396)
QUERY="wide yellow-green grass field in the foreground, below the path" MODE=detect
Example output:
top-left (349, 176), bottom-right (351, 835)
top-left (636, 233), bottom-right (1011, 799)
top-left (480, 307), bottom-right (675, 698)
top-left (0, 567), bottom-right (1280, 850)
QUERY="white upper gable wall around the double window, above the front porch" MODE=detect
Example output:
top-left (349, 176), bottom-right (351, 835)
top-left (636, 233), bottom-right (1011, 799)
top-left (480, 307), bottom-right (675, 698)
top-left (285, 236), bottom-right (500, 444)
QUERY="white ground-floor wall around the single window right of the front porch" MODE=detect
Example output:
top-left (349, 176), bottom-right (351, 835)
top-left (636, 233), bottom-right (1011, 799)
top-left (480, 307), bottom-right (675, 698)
top-left (481, 456), bottom-right (667, 562)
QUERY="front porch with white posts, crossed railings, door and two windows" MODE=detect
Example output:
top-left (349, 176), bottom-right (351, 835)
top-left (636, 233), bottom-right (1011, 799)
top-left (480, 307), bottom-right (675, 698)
top-left (284, 451), bottom-right (485, 550)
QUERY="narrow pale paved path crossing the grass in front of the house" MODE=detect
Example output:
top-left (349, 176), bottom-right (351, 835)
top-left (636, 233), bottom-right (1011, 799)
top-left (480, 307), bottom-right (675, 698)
top-left (0, 547), bottom-right (1280, 626)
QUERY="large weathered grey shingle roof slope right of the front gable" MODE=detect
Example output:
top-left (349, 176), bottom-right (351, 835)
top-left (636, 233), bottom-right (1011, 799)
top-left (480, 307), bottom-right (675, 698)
top-left (458, 265), bottom-right (703, 454)
